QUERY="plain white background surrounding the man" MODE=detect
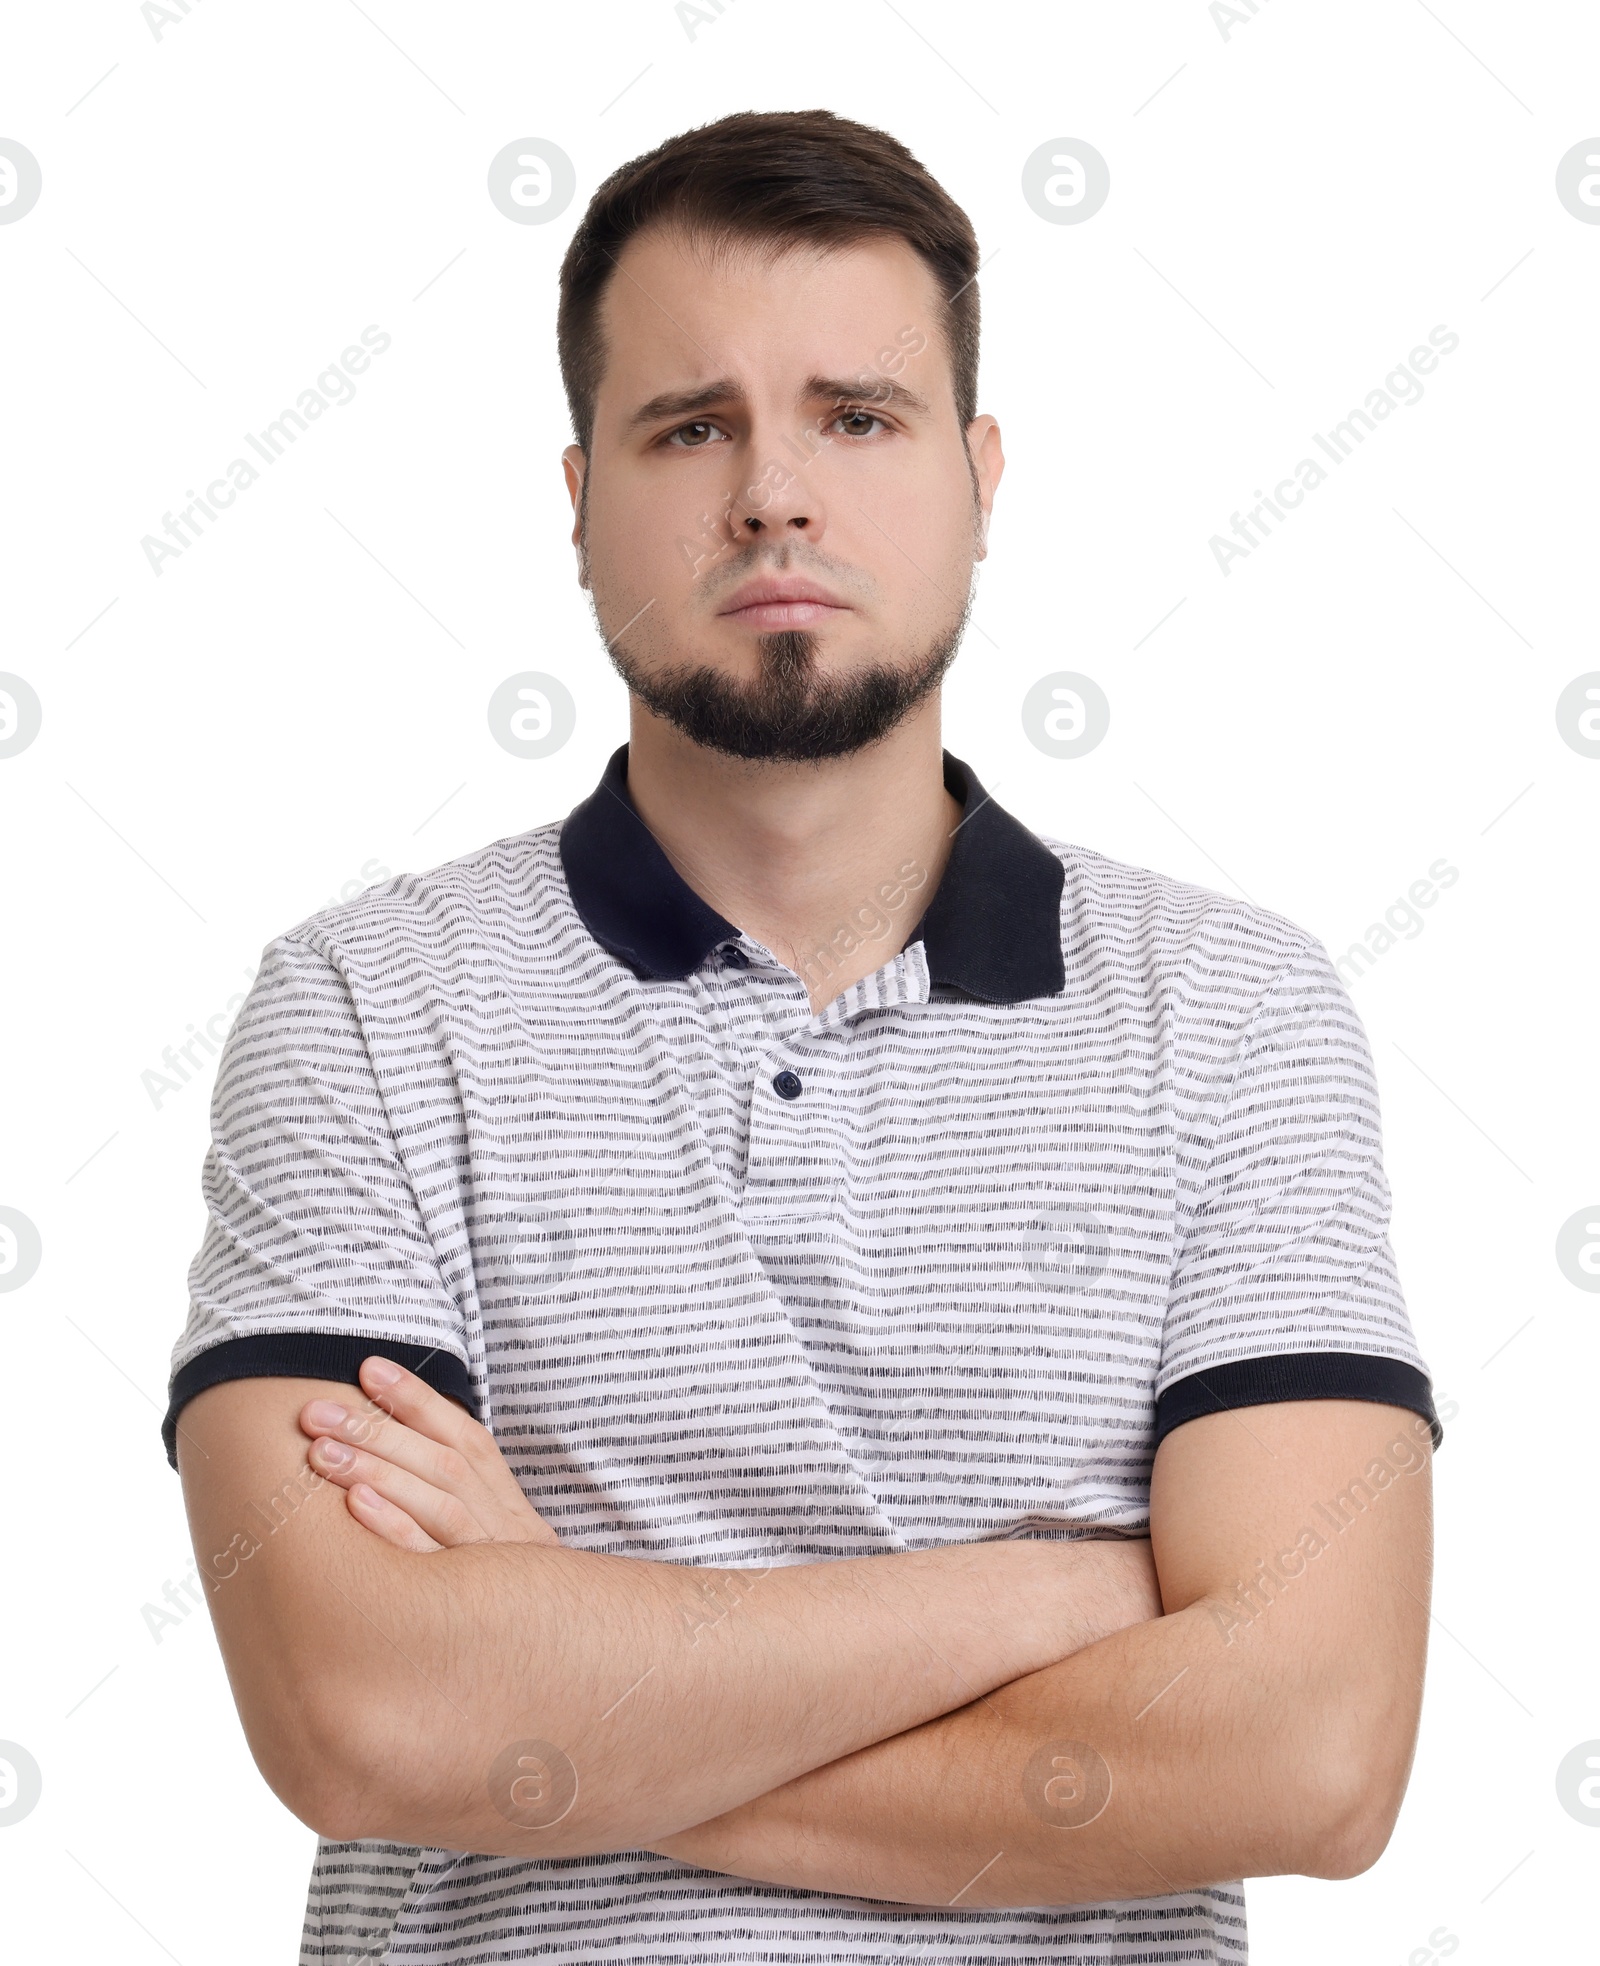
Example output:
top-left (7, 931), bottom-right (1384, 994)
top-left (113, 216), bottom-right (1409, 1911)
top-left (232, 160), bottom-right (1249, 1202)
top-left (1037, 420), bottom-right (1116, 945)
top-left (0, 0), bottom-right (1600, 1966)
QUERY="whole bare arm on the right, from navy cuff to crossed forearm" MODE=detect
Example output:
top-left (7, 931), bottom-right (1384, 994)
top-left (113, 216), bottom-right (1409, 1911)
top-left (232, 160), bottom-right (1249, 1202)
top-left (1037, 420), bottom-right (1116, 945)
top-left (655, 1406), bottom-right (1429, 1905)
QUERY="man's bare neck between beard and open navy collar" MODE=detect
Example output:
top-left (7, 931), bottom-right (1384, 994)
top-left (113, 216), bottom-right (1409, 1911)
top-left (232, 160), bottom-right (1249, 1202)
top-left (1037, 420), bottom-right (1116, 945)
top-left (627, 696), bottom-right (961, 1009)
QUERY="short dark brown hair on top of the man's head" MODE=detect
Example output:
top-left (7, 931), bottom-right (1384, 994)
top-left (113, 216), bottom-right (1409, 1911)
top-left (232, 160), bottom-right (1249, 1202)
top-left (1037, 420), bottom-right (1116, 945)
top-left (556, 110), bottom-right (979, 450)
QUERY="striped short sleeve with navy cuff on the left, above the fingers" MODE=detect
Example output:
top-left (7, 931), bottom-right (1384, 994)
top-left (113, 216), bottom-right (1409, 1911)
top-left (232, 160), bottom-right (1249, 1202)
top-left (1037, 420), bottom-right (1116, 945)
top-left (161, 936), bottom-right (474, 1467)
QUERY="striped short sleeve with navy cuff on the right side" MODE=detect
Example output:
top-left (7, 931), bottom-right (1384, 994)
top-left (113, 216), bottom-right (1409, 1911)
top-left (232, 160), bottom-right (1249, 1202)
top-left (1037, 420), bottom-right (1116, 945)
top-left (1156, 927), bottom-right (1441, 1443)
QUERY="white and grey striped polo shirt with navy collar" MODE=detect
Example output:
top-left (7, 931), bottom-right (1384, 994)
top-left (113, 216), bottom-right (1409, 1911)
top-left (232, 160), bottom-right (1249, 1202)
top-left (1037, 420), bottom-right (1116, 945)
top-left (163, 747), bottom-right (1437, 1966)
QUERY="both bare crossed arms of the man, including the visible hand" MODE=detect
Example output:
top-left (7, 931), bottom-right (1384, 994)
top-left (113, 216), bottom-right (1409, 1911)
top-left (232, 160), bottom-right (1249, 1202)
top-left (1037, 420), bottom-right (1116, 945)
top-left (179, 1360), bottom-right (1431, 1907)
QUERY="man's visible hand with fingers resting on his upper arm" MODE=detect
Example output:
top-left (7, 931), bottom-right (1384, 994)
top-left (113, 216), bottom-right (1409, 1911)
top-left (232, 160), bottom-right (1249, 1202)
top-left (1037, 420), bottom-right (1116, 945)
top-left (301, 1357), bottom-right (558, 1555)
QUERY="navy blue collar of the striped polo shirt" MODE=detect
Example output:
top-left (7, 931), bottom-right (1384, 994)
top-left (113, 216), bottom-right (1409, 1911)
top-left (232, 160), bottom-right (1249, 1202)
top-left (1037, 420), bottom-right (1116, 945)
top-left (560, 745), bottom-right (1065, 1003)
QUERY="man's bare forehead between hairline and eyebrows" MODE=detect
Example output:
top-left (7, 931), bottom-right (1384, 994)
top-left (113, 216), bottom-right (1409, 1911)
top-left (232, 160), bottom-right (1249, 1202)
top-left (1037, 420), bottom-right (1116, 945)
top-left (596, 228), bottom-right (949, 423)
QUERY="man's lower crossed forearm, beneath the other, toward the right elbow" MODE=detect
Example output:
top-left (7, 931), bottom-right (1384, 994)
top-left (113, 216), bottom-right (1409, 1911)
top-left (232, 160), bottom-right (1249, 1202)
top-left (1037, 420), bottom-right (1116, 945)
top-left (653, 1606), bottom-right (1413, 1905)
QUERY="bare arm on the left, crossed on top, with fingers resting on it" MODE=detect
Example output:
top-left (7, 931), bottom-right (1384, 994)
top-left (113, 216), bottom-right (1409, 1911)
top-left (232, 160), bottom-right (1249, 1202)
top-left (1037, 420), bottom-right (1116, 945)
top-left (179, 1360), bottom-right (1160, 1856)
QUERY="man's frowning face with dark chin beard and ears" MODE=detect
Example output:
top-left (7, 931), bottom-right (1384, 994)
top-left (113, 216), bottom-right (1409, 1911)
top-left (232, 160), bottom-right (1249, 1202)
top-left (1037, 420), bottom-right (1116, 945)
top-left (566, 230), bottom-right (1002, 759)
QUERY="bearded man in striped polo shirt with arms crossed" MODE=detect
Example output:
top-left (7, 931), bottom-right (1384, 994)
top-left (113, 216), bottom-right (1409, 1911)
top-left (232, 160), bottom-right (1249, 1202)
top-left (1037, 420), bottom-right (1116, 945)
top-left (165, 112), bottom-right (1437, 1962)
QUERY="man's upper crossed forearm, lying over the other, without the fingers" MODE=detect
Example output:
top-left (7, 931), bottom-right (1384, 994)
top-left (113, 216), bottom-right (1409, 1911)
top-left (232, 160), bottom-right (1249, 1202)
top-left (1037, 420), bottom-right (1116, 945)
top-left (324, 1543), bottom-right (1130, 1856)
